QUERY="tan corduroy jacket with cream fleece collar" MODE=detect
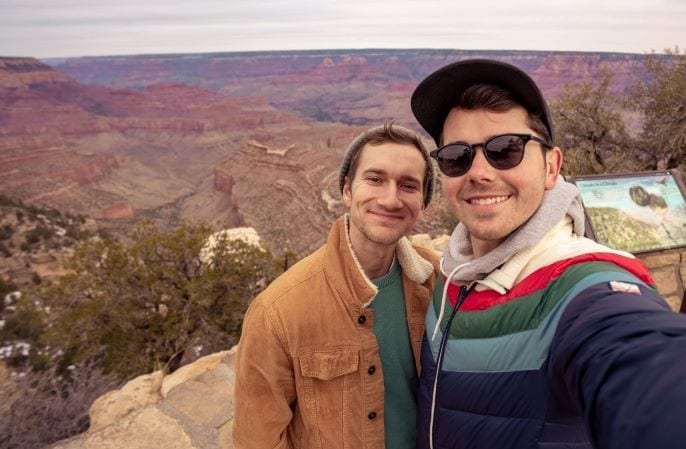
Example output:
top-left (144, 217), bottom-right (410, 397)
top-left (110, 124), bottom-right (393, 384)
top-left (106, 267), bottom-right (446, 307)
top-left (233, 217), bottom-right (437, 449)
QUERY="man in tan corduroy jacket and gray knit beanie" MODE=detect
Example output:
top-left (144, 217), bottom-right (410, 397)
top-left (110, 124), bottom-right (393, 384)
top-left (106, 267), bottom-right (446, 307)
top-left (233, 125), bottom-right (438, 449)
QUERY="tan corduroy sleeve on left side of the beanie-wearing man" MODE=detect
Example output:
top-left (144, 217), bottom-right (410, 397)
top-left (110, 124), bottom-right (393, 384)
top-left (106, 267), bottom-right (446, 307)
top-left (233, 299), bottom-right (296, 449)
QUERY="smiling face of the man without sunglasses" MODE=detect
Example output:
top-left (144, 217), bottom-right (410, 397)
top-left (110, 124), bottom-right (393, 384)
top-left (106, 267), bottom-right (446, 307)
top-left (343, 142), bottom-right (426, 254)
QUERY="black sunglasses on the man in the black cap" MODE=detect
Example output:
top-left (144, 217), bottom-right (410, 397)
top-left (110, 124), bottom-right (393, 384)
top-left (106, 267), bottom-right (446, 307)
top-left (430, 134), bottom-right (553, 177)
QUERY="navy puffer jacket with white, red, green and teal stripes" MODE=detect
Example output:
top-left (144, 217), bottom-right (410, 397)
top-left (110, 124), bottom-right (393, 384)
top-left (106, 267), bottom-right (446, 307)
top-left (418, 215), bottom-right (686, 449)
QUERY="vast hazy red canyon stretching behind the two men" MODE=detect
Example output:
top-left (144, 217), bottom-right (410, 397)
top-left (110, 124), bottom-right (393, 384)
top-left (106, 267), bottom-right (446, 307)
top-left (0, 50), bottom-right (656, 257)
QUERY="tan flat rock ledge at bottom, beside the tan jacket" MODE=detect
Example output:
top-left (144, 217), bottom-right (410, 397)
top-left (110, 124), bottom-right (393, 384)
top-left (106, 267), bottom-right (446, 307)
top-left (49, 347), bottom-right (236, 449)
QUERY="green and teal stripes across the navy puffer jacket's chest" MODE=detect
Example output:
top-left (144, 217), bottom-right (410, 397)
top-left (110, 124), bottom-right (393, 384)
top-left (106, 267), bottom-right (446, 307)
top-left (426, 262), bottom-right (645, 373)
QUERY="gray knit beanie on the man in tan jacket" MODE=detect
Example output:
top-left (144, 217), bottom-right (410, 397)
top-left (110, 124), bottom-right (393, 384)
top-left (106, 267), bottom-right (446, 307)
top-left (338, 123), bottom-right (436, 208)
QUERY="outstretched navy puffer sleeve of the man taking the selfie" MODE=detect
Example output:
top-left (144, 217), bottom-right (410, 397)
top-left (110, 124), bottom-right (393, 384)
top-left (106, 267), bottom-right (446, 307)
top-left (549, 283), bottom-right (686, 449)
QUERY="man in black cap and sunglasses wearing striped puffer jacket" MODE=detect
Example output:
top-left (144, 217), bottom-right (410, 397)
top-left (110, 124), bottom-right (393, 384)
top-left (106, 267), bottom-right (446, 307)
top-left (412, 60), bottom-right (686, 449)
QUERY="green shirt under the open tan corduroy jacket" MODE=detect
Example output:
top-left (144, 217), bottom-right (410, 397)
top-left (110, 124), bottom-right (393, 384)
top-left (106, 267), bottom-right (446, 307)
top-left (370, 261), bottom-right (418, 449)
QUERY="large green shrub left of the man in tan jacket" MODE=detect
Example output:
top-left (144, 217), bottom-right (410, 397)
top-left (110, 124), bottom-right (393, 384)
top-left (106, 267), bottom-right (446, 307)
top-left (33, 223), bottom-right (278, 379)
